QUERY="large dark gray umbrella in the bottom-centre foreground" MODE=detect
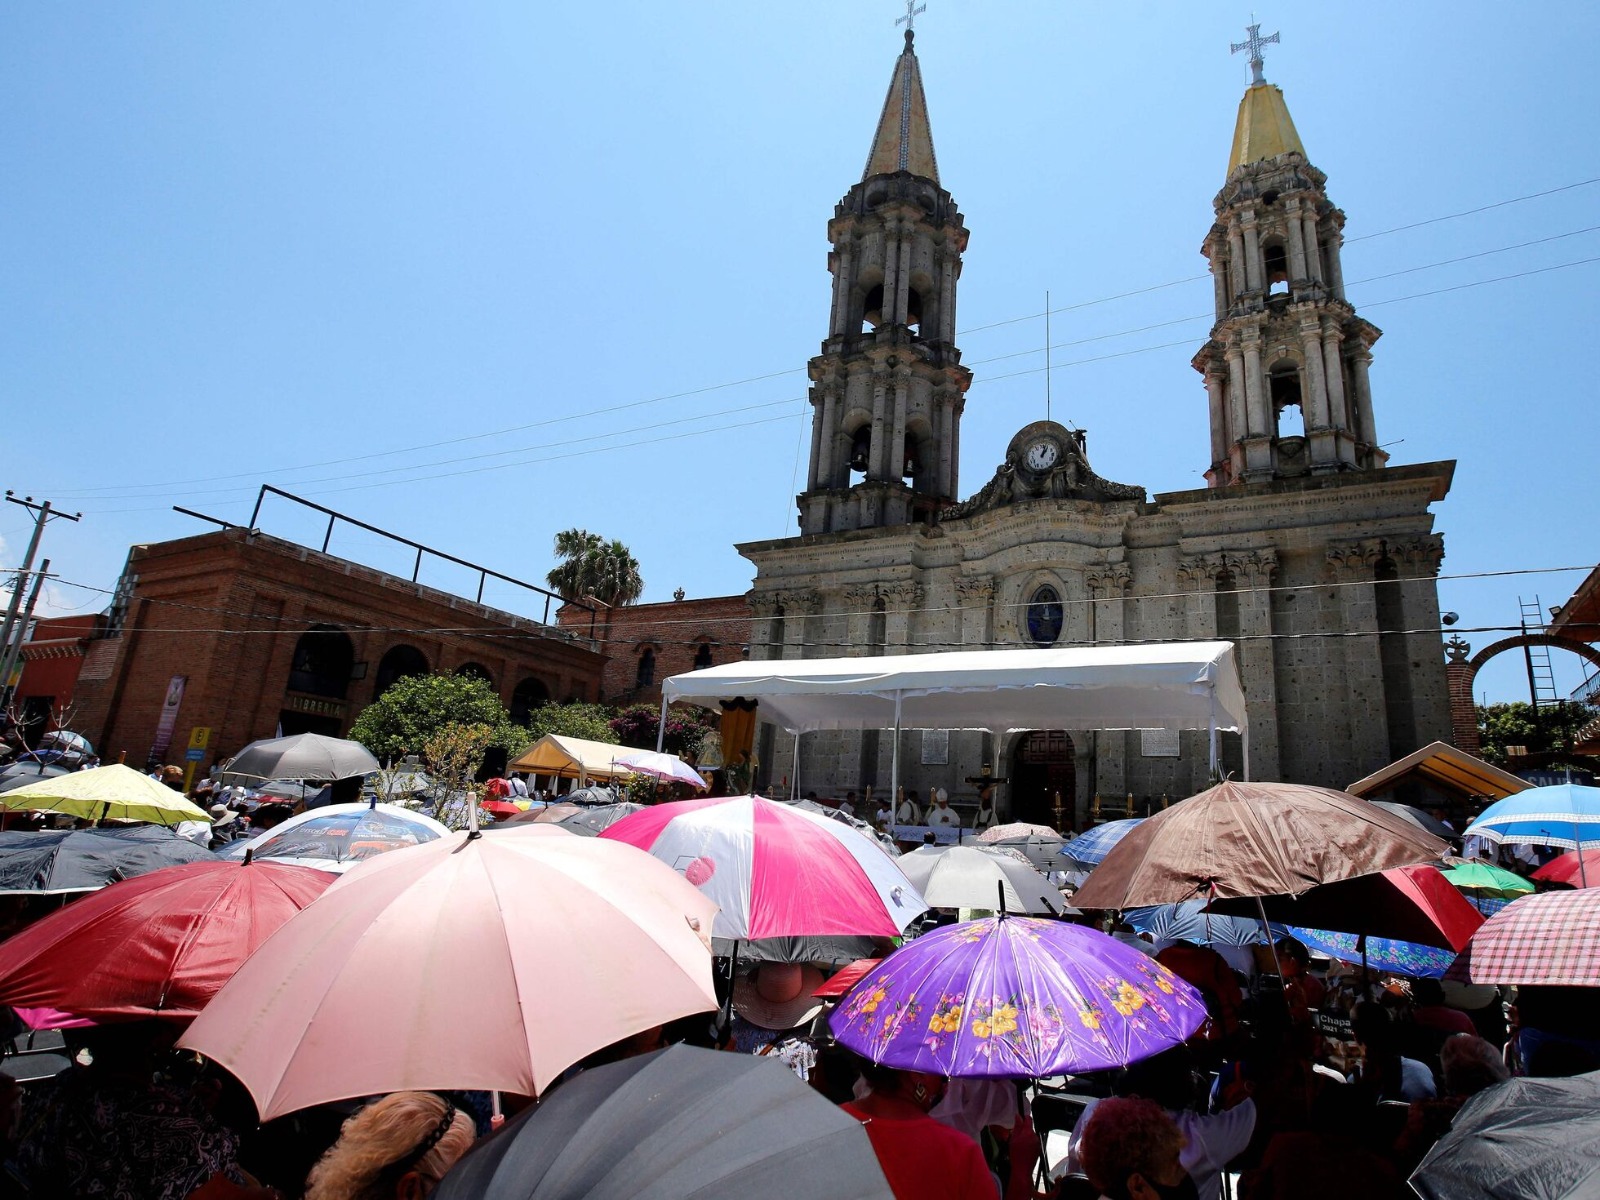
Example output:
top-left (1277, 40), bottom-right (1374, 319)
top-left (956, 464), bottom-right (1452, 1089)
top-left (432, 1046), bottom-right (893, 1200)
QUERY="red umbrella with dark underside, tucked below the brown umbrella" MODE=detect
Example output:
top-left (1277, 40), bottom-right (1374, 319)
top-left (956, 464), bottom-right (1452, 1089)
top-left (1208, 866), bottom-right (1483, 950)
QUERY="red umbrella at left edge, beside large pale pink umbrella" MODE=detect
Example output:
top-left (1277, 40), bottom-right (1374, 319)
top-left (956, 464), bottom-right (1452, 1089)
top-left (0, 859), bottom-right (336, 1019)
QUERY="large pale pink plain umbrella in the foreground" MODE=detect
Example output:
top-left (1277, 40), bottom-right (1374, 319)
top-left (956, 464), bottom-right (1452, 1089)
top-left (181, 826), bottom-right (717, 1120)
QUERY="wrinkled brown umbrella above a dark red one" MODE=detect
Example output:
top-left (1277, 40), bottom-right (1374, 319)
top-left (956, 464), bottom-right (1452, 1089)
top-left (1072, 781), bottom-right (1450, 909)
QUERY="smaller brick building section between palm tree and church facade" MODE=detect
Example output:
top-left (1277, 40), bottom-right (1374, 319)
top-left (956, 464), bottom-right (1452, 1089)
top-left (555, 595), bottom-right (750, 706)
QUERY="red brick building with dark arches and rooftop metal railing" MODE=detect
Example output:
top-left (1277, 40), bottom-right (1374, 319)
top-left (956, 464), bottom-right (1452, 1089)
top-left (74, 528), bottom-right (603, 768)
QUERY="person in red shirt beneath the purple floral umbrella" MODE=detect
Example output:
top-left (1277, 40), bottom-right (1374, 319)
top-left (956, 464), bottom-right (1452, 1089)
top-left (840, 1062), bottom-right (1000, 1200)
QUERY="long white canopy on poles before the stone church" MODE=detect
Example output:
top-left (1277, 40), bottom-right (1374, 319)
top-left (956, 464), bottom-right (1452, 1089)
top-left (661, 642), bottom-right (1246, 734)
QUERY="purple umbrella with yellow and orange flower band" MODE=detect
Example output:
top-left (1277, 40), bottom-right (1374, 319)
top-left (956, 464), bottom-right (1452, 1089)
top-left (829, 917), bottom-right (1206, 1078)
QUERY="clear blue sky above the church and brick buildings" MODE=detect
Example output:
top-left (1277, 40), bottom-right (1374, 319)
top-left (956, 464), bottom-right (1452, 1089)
top-left (0, 0), bottom-right (1600, 698)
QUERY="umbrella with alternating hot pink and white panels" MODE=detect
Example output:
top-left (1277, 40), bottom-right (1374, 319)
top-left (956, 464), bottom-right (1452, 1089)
top-left (600, 795), bottom-right (928, 939)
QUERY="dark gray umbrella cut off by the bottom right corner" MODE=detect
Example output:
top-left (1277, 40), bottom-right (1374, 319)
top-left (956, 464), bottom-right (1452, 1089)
top-left (1410, 1072), bottom-right (1600, 1200)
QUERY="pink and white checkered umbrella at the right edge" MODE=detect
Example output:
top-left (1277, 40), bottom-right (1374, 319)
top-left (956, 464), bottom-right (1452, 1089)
top-left (1445, 888), bottom-right (1600, 987)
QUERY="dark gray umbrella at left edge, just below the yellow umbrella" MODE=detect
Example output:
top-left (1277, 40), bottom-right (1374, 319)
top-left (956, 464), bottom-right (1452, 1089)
top-left (0, 826), bottom-right (211, 894)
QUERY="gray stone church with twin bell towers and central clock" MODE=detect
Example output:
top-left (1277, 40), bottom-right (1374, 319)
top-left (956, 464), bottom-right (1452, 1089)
top-left (738, 30), bottom-right (1454, 826)
